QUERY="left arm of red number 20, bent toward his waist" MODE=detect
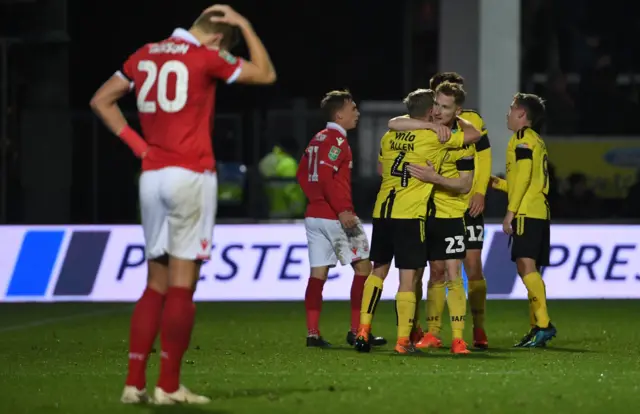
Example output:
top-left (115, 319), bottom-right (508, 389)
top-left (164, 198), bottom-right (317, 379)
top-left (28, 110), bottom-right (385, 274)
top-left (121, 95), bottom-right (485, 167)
top-left (90, 70), bottom-right (148, 158)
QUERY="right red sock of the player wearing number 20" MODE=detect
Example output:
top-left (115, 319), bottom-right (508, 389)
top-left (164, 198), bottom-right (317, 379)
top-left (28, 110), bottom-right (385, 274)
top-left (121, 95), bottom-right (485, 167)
top-left (158, 287), bottom-right (195, 393)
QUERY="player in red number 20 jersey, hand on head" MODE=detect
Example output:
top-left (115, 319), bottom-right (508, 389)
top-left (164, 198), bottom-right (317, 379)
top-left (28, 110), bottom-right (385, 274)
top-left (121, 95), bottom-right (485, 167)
top-left (91, 5), bottom-right (276, 404)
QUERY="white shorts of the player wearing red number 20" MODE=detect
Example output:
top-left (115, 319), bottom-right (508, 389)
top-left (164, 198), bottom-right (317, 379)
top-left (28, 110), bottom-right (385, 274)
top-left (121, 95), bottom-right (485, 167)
top-left (140, 167), bottom-right (218, 260)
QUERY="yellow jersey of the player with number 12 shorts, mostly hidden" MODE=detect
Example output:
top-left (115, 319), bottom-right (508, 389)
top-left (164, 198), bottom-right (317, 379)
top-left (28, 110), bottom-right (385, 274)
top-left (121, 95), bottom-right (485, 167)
top-left (460, 109), bottom-right (491, 205)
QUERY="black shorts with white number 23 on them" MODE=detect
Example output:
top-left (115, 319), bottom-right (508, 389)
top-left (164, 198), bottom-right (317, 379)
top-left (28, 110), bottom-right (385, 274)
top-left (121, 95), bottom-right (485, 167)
top-left (427, 216), bottom-right (467, 261)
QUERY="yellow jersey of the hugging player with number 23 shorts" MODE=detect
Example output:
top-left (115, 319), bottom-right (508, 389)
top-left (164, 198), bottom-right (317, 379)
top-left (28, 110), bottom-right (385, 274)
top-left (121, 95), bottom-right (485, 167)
top-left (429, 145), bottom-right (476, 218)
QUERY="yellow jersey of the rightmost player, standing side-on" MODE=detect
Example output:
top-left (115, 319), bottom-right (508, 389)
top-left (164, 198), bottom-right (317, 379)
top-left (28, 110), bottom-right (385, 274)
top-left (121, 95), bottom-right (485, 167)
top-left (507, 127), bottom-right (551, 220)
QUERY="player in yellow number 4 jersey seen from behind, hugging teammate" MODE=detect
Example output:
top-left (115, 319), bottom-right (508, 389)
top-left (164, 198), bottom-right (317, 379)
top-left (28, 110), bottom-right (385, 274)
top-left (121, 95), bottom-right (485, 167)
top-left (356, 89), bottom-right (480, 354)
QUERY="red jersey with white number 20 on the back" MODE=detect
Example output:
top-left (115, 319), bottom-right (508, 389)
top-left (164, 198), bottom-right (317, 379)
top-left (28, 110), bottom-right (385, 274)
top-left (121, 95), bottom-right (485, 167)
top-left (117, 29), bottom-right (242, 172)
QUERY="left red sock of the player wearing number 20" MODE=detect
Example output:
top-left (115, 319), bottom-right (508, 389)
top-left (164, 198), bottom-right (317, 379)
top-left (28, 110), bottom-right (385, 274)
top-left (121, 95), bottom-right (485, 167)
top-left (126, 288), bottom-right (164, 390)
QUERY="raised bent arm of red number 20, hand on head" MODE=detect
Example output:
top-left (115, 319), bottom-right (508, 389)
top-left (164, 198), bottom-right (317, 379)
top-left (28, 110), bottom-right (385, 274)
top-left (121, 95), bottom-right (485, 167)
top-left (205, 4), bottom-right (277, 85)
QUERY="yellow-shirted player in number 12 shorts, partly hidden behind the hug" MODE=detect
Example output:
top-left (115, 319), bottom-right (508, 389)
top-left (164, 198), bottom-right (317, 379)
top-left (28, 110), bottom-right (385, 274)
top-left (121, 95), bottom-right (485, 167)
top-left (389, 72), bottom-right (491, 349)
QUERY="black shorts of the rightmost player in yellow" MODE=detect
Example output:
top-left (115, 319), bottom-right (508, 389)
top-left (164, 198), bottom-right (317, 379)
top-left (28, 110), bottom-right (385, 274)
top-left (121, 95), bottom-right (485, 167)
top-left (511, 217), bottom-right (551, 266)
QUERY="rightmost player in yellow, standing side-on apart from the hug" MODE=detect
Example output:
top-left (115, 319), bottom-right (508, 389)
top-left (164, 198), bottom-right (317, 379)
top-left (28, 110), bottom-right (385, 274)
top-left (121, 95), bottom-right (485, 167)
top-left (493, 93), bottom-right (556, 348)
